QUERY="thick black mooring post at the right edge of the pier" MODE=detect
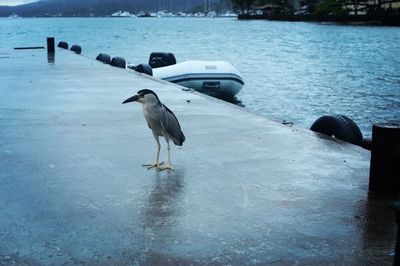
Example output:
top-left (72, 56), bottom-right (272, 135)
top-left (369, 123), bottom-right (400, 194)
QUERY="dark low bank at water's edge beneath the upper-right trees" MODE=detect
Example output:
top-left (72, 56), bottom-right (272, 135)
top-left (238, 14), bottom-right (400, 26)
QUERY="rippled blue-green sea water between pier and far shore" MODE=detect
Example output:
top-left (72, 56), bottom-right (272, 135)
top-left (0, 18), bottom-right (400, 137)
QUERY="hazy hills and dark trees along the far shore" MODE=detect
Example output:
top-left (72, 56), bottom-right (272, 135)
top-left (0, 0), bottom-right (400, 19)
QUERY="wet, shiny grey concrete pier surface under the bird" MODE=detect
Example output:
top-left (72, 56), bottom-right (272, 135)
top-left (0, 50), bottom-right (396, 265)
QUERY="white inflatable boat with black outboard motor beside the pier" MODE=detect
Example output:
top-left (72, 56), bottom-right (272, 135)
top-left (130, 53), bottom-right (244, 97)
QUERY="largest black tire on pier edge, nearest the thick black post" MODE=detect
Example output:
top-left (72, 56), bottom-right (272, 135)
top-left (310, 115), bottom-right (363, 146)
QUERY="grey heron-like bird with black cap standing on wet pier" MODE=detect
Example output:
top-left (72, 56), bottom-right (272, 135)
top-left (122, 89), bottom-right (185, 171)
